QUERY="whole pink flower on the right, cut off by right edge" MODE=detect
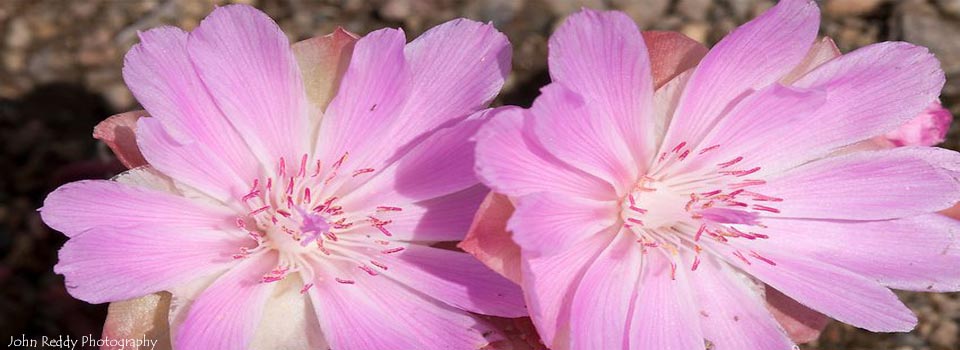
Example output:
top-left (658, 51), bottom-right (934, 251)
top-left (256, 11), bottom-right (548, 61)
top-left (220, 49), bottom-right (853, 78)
top-left (472, 0), bottom-right (960, 349)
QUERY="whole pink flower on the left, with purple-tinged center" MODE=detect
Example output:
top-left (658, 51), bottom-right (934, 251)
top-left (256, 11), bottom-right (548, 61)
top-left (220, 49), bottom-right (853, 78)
top-left (42, 6), bottom-right (526, 349)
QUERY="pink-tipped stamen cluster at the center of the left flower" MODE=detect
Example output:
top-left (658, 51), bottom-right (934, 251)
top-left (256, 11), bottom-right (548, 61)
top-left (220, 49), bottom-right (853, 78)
top-left (233, 153), bottom-right (404, 293)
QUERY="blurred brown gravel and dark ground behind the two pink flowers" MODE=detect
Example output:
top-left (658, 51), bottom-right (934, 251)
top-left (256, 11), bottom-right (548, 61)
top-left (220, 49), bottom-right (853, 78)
top-left (0, 0), bottom-right (960, 350)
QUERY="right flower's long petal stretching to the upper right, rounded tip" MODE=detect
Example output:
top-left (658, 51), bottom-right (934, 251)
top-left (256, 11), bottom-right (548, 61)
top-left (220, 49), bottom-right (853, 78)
top-left (772, 42), bottom-right (944, 169)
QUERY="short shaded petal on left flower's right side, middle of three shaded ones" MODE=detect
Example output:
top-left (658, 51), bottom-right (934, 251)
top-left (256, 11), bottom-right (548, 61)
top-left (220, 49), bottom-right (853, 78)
top-left (377, 184), bottom-right (490, 242)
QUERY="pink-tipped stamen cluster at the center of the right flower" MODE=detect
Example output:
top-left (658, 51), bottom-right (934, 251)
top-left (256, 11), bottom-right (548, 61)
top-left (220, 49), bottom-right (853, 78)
top-left (621, 142), bottom-right (783, 278)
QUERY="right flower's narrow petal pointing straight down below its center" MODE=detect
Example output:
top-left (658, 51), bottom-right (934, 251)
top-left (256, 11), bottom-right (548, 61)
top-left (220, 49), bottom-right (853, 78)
top-left (632, 250), bottom-right (704, 349)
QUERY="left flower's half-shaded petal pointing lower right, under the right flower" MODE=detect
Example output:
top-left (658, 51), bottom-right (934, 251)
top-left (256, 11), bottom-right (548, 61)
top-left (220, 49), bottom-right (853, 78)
top-left (380, 245), bottom-right (527, 317)
